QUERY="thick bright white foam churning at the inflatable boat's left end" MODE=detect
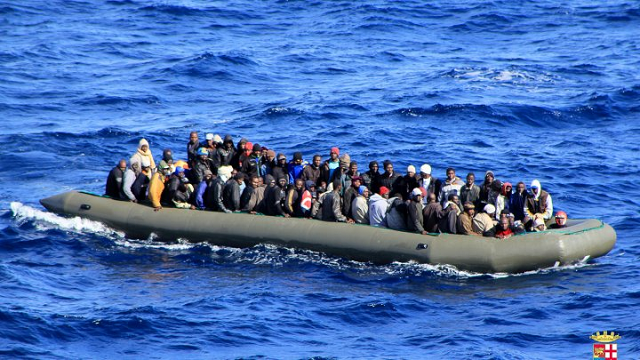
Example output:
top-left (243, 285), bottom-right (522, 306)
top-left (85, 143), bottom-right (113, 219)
top-left (10, 202), bottom-right (124, 238)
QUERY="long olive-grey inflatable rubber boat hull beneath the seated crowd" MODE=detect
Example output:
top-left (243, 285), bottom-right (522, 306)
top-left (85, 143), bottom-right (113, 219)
top-left (40, 191), bottom-right (616, 273)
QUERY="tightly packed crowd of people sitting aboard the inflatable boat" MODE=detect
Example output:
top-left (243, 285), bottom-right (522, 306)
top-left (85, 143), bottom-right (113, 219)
top-left (105, 131), bottom-right (567, 238)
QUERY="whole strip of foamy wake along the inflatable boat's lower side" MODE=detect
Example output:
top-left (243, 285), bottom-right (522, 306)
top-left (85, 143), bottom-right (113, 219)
top-left (10, 202), bottom-right (595, 279)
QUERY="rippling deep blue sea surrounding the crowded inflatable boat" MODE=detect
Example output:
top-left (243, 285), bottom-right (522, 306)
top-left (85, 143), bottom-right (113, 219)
top-left (0, 0), bottom-right (640, 360)
